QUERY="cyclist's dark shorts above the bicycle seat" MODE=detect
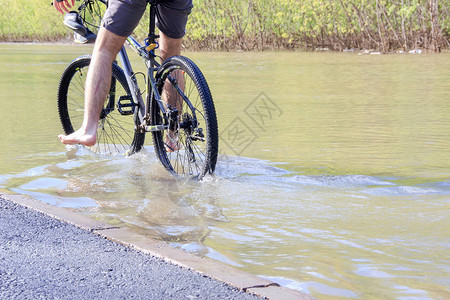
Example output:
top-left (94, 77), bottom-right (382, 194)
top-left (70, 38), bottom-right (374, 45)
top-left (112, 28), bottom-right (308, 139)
top-left (103, 0), bottom-right (193, 39)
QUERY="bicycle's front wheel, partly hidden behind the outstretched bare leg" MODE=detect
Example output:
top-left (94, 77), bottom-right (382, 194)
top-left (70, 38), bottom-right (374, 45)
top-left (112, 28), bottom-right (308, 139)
top-left (58, 55), bottom-right (145, 156)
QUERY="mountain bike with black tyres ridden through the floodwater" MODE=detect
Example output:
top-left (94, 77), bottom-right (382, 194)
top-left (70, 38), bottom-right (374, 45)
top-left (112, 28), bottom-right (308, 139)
top-left (58, 0), bottom-right (219, 179)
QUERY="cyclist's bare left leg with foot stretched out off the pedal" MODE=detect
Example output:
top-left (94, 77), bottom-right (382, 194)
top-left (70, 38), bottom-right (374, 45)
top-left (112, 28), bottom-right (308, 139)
top-left (58, 28), bottom-right (126, 146)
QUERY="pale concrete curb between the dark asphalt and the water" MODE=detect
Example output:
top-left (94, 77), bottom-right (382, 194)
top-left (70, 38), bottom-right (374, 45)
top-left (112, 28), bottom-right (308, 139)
top-left (0, 193), bottom-right (315, 300)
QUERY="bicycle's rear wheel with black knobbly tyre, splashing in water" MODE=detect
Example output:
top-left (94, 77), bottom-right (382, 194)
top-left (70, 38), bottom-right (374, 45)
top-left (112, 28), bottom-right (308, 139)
top-left (150, 56), bottom-right (219, 179)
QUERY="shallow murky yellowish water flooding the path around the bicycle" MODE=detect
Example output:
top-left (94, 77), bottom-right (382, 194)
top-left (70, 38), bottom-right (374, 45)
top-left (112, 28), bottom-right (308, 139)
top-left (0, 45), bottom-right (450, 299)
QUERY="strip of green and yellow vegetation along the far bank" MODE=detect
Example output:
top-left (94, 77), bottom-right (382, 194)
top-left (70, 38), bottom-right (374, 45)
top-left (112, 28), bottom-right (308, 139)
top-left (0, 0), bottom-right (450, 52)
